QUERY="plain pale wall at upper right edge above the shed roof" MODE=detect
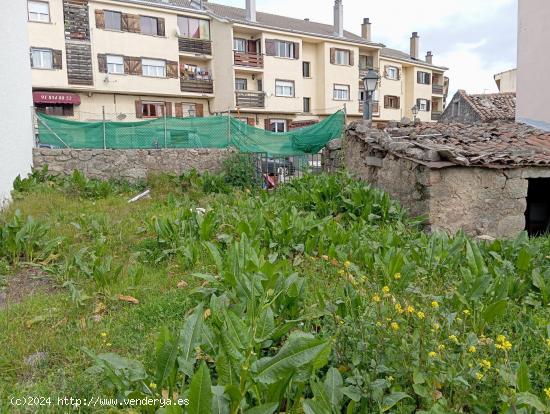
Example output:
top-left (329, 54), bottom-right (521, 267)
top-left (516, 0), bottom-right (550, 131)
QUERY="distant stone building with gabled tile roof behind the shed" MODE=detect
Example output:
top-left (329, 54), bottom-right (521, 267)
top-left (440, 90), bottom-right (516, 123)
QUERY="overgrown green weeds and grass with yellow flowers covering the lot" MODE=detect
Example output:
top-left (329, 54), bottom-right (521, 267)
top-left (0, 169), bottom-right (550, 414)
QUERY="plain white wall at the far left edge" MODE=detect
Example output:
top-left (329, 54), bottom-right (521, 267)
top-left (0, 0), bottom-right (33, 203)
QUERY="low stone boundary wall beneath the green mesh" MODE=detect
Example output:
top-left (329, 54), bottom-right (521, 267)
top-left (33, 148), bottom-right (233, 181)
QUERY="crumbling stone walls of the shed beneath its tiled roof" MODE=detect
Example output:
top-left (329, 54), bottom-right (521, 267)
top-left (343, 124), bottom-right (550, 238)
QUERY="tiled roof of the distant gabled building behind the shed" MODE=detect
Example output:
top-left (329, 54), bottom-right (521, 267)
top-left (457, 90), bottom-right (516, 122)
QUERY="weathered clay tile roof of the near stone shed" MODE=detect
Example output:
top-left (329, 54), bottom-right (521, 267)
top-left (348, 122), bottom-right (550, 168)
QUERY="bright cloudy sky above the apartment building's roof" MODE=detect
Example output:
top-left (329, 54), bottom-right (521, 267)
top-left (212, 0), bottom-right (517, 98)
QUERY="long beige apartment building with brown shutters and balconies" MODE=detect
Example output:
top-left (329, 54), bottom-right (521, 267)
top-left (27, 0), bottom-right (448, 132)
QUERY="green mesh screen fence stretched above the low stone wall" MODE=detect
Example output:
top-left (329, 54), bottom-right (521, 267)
top-left (38, 111), bottom-right (345, 155)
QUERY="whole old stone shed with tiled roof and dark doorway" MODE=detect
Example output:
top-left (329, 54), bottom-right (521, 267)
top-left (343, 122), bottom-right (550, 237)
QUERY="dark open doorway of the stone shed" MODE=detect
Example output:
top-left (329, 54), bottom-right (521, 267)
top-left (525, 178), bottom-right (550, 236)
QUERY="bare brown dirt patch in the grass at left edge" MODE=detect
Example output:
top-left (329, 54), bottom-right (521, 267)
top-left (0, 267), bottom-right (57, 309)
